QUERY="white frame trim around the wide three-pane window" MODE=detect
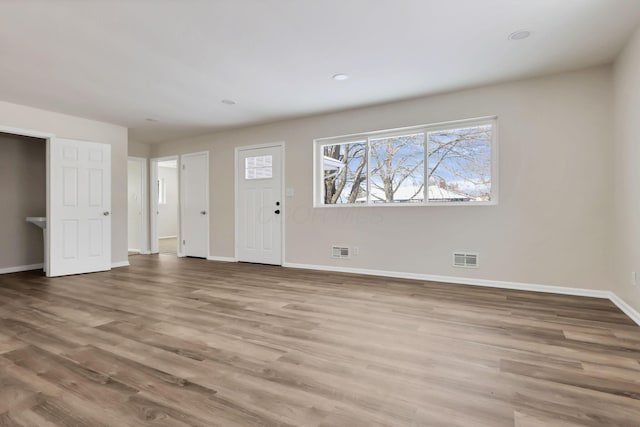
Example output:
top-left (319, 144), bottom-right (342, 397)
top-left (313, 116), bottom-right (499, 209)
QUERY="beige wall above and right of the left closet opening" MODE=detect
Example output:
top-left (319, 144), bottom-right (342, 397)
top-left (0, 101), bottom-right (127, 263)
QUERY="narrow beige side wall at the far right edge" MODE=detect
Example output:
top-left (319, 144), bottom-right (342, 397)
top-left (610, 29), bottom-right (640, 311)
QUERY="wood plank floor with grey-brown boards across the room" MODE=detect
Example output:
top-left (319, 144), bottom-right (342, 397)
top-left (0, 255), bottom-right (640, 427)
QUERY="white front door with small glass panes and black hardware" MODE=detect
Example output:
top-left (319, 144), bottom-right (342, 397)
top-left (236, 146), bottom-right (283, 265)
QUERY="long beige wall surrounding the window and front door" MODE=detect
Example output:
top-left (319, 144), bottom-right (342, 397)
top-left (151, 67), bottom-right (613, 289)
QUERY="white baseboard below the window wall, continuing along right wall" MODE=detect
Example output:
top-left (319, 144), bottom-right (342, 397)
top-left (282, 263), bottom-right (640, 326)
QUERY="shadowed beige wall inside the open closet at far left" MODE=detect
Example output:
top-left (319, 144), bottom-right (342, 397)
top-left (0, 133), bottom-right (47, 269)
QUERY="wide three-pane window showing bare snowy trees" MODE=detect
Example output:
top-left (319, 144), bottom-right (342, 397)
top-left (315, 118), bottom-right (496, 206)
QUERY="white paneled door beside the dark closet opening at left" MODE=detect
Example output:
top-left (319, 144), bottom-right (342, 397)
top-left (47, 138), bottom-right (111, 276)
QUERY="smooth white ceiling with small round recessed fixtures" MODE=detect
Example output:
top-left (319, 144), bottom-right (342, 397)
top-left (0, 0), bottom-right (640, 142)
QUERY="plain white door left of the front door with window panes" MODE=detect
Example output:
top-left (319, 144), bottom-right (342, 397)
top-left (180, 152), bottom-right (209, 258)
